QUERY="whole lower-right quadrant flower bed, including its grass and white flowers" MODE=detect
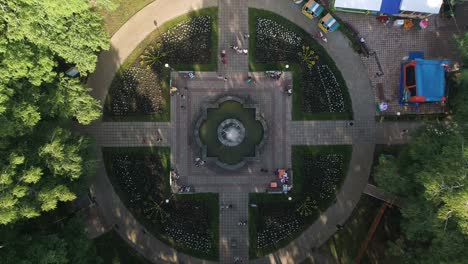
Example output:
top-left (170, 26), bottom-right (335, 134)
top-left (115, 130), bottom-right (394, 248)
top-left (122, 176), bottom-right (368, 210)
top-left (249, 146), bottom-right (351, 258)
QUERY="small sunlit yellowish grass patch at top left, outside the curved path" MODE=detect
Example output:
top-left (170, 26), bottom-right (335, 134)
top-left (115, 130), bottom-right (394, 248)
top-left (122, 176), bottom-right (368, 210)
top-left (99, 0), bottom-right (155, 37)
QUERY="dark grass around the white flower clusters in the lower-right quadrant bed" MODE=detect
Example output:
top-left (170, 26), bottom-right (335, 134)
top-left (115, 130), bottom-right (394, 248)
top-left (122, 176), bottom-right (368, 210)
top-left (249, 145), bottom-right (352, 258)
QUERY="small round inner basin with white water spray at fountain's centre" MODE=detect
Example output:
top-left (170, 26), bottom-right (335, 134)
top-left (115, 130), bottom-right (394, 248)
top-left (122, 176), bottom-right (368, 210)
top-left (218, 118), bottom-right (245, 147)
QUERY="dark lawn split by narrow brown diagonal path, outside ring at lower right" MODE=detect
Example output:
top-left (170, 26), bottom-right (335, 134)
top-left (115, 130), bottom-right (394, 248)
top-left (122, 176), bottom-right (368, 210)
top-left (318, 195), bottom-right (400, 264)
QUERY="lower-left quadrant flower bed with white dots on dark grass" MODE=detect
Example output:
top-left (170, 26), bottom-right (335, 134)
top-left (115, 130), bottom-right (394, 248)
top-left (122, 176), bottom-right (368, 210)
top-left (103, 148), bottom-right (218, 259)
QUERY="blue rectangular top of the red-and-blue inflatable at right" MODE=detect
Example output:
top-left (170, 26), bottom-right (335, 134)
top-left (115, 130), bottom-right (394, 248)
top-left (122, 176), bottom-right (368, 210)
top-left (415, 59), bottom-right (450, 102)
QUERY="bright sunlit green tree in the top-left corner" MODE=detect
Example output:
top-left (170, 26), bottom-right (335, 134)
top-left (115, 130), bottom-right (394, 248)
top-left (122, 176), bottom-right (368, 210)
top-left (0, 0), bottom-right (109, 86)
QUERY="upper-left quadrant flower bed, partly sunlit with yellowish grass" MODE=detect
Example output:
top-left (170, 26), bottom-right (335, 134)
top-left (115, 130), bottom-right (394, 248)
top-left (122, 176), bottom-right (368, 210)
top-left (104, 11), bottom-right (217, 121)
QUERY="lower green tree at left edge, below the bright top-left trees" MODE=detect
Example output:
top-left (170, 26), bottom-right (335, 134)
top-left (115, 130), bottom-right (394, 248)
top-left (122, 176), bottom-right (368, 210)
top-left (0, 125), bottom-right (94, 224)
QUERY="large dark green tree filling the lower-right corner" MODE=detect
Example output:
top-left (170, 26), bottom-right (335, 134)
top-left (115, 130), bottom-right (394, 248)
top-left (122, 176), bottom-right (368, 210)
top-left (376, 120), bottom-right (468, 263)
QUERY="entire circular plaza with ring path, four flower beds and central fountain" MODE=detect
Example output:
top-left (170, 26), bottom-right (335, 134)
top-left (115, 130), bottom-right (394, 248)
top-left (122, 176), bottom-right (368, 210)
top-left (85, 1), bottom-right (375, 263)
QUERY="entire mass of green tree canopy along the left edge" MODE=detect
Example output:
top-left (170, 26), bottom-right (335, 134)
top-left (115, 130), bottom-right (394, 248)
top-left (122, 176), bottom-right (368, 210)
top-left (0, 0), bottom-right (109, 224)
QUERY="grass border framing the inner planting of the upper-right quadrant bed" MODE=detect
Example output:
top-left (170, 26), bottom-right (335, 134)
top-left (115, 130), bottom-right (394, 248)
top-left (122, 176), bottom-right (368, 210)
top-left (249, 8), bottom-right (353, 121)
